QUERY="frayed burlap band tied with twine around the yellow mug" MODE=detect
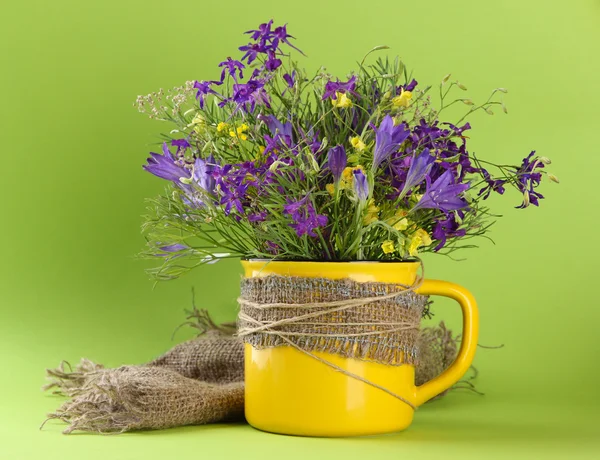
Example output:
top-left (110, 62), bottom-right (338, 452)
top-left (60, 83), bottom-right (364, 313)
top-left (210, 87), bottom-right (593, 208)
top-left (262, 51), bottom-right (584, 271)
top-left (238, 275), bottom-right (428, 366)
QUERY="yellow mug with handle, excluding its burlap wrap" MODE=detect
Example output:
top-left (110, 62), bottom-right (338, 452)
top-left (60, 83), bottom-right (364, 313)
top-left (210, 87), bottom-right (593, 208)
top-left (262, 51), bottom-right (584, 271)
top-left (242, 260), bottom-right (478, 436)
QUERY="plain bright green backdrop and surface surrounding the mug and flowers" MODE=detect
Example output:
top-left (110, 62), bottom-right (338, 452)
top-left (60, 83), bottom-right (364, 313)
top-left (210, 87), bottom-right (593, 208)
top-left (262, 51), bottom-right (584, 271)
top-left (0, 0), bottom-right (600, 460)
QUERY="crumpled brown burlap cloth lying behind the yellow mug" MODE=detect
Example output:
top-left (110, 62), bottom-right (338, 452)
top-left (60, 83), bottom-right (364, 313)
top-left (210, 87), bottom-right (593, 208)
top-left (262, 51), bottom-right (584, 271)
top-left (44, 309), bottom-right (468, 434)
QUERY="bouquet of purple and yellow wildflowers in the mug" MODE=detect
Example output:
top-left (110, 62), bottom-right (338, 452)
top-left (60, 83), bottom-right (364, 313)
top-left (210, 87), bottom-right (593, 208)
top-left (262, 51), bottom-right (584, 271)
top-left (136, 21), bottom-right (557, 279)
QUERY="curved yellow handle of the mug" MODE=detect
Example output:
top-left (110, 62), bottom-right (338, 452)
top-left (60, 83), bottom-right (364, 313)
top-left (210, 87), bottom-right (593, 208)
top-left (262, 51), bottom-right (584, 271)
top-left (416, 280), bottom-right (479, 406)
